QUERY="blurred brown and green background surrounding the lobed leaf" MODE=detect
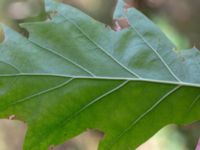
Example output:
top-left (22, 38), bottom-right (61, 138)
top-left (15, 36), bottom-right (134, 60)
top-left (0, 0), bottom-right (200, 150)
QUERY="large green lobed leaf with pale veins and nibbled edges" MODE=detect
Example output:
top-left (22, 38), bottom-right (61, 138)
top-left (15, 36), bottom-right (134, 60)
top-left (0, 1), bottom-right (200, 150)
